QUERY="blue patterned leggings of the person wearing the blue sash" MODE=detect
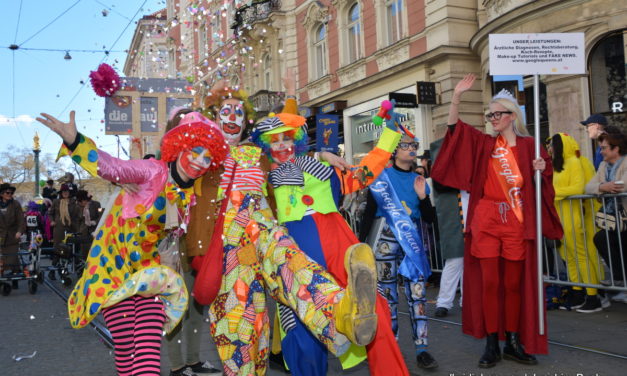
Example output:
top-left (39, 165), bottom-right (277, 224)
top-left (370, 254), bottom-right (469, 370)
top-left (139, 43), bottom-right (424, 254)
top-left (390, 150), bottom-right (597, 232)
top-left (374, 224), bottom-right (428, 354)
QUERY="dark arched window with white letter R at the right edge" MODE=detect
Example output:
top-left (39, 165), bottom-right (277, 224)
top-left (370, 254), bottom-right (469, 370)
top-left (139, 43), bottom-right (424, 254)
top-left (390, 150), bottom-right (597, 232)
top-left (588, 29), bottom-right (627, 131)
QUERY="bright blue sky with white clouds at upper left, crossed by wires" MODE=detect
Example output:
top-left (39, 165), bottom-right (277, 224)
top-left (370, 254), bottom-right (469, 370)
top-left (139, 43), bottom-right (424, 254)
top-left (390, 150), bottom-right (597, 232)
top-left (0, 0), bottom-right (166, 169)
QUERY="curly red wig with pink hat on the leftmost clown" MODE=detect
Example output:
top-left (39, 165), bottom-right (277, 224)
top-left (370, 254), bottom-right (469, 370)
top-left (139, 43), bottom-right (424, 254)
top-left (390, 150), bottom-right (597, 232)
top-left (161, 112), bottom-right (228, 170)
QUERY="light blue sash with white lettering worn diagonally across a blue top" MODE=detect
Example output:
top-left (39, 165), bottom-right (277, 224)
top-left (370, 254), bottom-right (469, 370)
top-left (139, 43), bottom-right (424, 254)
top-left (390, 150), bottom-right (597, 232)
top-left (370, 171), bottom-right (431, 281)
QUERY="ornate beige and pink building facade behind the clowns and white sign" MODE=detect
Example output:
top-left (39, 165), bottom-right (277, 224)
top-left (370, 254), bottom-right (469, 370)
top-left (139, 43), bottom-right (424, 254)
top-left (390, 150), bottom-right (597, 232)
top-left (161, 0), bottom-right (627, 160)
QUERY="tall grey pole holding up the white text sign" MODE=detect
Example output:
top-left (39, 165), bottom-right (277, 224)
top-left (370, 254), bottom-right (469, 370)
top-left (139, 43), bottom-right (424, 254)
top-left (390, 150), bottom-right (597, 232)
top-left (533, 74), bottom-right (544, 336)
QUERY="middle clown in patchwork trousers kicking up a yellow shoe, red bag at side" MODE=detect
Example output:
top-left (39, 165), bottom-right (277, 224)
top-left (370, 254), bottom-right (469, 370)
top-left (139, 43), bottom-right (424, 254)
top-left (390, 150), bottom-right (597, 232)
top-left (186, 78), bottom-right (375, 375)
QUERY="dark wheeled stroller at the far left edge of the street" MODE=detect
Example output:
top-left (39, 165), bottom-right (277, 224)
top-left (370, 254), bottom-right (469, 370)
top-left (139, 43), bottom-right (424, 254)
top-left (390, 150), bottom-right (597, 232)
top-left (0, 235), bottom-right (43, 296)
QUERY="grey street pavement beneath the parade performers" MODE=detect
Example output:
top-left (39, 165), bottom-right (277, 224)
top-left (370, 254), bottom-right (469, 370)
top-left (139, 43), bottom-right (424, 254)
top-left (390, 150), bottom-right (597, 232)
top-left (0, 270), bottom-right (627, 376)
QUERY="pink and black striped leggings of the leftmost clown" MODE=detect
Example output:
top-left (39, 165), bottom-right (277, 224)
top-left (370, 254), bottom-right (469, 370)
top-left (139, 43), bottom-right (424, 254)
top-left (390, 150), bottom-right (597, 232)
top-left (102, 295), bottom-right (165, 376)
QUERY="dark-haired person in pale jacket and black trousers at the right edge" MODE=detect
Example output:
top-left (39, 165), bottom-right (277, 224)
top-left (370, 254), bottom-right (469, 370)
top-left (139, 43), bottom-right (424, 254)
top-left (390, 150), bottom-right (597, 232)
top-left (578, 133), bottom-right (627, 306)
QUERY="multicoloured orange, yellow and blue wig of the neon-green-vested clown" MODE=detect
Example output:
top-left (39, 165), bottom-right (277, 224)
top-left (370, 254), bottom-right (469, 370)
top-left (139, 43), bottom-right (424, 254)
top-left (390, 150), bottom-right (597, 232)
top-left (251, 112), bottom-right (309, 162)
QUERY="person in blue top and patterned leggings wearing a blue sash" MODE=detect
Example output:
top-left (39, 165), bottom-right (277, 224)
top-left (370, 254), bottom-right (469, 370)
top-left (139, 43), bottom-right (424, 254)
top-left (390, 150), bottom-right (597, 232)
top-left (359, 134), bottom-right (438, 369)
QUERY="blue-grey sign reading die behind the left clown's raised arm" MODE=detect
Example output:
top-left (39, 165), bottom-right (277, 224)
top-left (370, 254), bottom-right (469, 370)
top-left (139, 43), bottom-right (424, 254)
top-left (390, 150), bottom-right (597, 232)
top-left (105, 77), bottom-right (193, 136)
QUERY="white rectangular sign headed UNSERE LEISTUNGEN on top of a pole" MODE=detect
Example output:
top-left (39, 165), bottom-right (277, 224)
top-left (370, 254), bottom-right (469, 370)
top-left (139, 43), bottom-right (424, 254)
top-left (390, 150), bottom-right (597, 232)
top-left (490, 33), bottom-right (586, 76)
